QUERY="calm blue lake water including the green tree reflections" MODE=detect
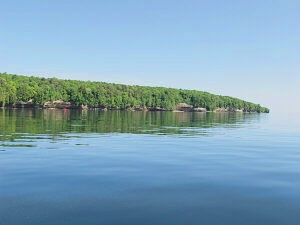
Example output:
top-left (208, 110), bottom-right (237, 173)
top-left (0, 109), bottom-right (300, 225)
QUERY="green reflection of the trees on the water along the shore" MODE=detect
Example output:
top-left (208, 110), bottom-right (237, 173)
top-left (0, 109), bottom-right (260, 141)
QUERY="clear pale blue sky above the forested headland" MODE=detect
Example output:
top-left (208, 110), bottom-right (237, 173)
top-left (0, 0), bottom-right (300, 111)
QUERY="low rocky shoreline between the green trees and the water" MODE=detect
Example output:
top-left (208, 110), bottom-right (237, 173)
top-left (2, 100), bottom-right (257, 113)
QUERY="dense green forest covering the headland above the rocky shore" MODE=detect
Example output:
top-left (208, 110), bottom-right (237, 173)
top-left (0, 73), bottom-right (269, 113)
